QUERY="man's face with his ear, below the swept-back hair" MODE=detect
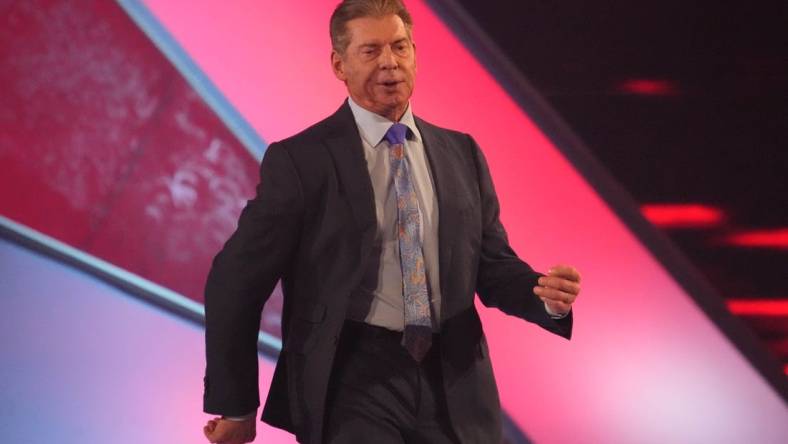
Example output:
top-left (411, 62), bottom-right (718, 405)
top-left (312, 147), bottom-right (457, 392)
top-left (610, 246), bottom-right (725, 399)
top-left (331, 15), bottom-right (416, 121)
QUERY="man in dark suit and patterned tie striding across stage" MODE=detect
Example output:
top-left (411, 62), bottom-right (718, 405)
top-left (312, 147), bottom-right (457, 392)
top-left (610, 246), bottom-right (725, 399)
top-left (204, 0), bottom-right (580, 444)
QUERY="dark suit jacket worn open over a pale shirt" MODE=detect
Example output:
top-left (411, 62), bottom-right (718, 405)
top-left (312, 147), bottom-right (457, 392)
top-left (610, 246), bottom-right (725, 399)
top-left (204, 102), bottom-right (572, 444)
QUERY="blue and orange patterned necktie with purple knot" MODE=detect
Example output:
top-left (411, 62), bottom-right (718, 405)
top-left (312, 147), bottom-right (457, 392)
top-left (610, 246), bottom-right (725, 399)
top-left (385, 123), bottom-right (432, 362)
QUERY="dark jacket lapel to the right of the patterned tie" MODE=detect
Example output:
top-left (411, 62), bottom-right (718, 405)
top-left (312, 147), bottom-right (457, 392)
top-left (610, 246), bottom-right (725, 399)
top-left (416, 118), bottom-right (461, 318)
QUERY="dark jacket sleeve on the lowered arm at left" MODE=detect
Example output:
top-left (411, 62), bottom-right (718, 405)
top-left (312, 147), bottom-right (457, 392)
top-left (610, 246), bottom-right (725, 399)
top-left (203, 144), bottom-right (304, 416)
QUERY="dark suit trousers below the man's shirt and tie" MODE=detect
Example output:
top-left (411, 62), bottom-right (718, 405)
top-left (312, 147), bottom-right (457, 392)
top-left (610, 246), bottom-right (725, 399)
top-left (323, 320), bottom-right (459, 444)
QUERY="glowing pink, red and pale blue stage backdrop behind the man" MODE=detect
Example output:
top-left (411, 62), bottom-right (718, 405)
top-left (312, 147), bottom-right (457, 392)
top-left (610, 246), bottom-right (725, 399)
top-left (0, 0), bottom-right (788, 443)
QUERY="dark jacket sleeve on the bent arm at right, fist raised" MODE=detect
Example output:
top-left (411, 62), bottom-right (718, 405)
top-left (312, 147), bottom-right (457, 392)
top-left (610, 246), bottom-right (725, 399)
top-left (468, 136), bottom-right (573, 339)
